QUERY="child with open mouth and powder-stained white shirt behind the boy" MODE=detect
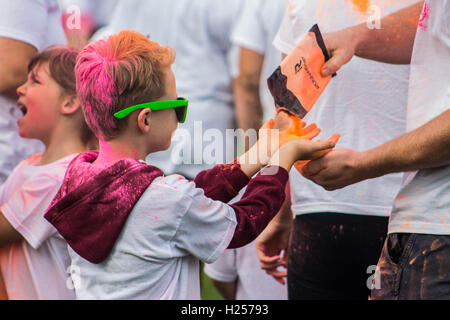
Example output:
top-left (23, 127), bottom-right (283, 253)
top-left (0, 48), bottom-right (90, 300)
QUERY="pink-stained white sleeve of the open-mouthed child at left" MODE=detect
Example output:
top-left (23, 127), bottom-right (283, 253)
top-left (0, 175), bottom-right (61, 249)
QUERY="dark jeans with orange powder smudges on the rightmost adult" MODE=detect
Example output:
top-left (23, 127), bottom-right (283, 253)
top-left (371, 233), bottom-right (450, 300)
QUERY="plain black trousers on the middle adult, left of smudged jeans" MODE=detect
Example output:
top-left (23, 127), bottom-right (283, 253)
top-left (288, 213), bottom-right (389, 300)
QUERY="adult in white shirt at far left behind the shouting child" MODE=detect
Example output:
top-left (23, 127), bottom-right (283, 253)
top-left (0, 0), bottom-right (66, 183)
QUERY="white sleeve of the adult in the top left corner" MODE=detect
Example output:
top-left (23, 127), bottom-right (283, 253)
top-left (0, 0), bottom-right (48, 51)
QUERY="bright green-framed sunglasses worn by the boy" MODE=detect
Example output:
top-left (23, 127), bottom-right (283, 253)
top-left (114, 97), bottom-right (189, 123)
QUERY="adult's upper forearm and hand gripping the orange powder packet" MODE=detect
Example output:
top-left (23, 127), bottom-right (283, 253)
top-left (322, 1), bottom-right (423, 76)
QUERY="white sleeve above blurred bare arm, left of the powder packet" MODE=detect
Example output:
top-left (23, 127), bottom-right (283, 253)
top-left (231, 0), bottom-right (266, 54)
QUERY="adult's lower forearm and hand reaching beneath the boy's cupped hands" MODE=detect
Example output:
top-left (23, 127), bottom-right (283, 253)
top-left (303, 110), bottom-right (450, 190)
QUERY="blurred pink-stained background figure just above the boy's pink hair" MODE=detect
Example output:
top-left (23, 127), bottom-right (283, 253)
top-left (58, 0), bottom-right (118, 49)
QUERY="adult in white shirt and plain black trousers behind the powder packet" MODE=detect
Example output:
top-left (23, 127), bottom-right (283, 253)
top-left (256, 0), bottom-right (412, 299)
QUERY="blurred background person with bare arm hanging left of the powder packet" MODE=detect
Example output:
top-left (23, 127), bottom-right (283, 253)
top-left (231, 0), bottom-right (288, 130)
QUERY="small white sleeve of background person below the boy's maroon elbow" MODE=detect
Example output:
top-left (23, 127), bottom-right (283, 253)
top-left (204, 249), bottom-right (238, 282)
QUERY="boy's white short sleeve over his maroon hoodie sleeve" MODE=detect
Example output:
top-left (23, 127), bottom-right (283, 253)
top-left (170, 176), bottom-right (236, 263)
